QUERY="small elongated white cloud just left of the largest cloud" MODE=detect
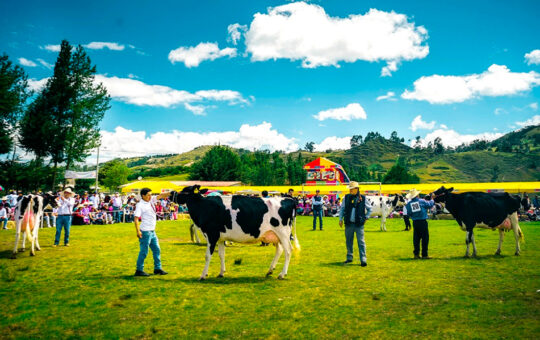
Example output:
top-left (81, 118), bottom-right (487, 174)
top-left (169, 43), bottom-right (236, 67)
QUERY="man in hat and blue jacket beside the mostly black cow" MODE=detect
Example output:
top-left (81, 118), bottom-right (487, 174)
top-left (405, 189), bottom-right (435, 259)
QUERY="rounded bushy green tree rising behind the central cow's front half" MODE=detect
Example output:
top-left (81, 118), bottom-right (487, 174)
top-left (189, 145), bottom-right (242, 181)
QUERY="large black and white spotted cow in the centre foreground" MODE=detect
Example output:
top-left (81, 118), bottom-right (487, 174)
top-left (170, 185), bottom-right (300, 280)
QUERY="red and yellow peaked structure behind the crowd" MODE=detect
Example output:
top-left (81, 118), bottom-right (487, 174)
top-left (304, 157), bottom-right (350, 185)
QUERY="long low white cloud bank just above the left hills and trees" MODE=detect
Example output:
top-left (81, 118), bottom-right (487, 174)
top-left (90, 122), bottom-right (298, 160)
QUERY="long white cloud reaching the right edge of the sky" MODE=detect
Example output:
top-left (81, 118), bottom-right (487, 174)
top-left (401, 64), bottom-right (540, 104)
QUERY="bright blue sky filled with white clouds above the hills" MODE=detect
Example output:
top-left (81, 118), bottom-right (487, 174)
top-left (0, 0), bottom-right (540, 161)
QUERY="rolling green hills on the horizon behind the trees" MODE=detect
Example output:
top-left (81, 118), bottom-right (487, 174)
top-left (112, 126), bottom-right (540, 183)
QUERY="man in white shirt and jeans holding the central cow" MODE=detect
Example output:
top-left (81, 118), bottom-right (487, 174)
top-left (133, 188), bottom-right (169, 276)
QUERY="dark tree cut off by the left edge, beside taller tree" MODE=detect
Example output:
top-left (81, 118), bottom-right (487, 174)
top-left (0, 54), bottom-right (30, 154)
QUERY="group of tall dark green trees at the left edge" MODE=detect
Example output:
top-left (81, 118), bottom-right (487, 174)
top-left (0, 40), bottom-right (110, 190)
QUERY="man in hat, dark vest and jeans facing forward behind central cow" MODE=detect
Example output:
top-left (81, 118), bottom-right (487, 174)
top-left (339, 182), bottom-right (371, 267)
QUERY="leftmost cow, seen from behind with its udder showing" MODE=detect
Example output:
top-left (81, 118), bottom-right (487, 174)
top-left (12, 194), bottom-right (58, 258)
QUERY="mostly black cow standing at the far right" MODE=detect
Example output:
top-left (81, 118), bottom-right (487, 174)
top-left (433, 186), bottom-right (523, 257)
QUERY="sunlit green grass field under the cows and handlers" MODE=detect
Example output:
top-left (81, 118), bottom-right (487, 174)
top-left (0, 217), bottom-right (540, 339)
